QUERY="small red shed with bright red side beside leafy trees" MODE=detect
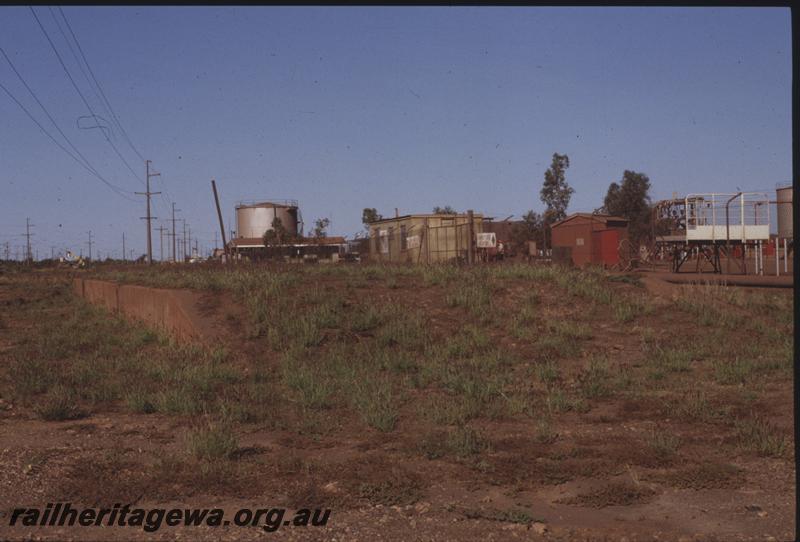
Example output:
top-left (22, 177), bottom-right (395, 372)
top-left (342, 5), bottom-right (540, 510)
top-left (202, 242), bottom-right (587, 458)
top-left (551, 213), bottom-right (628, 267)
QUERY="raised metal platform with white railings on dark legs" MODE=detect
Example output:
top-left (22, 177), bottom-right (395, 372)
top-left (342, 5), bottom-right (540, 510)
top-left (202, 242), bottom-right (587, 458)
top-left (651, 192), bottom-right (770, 273)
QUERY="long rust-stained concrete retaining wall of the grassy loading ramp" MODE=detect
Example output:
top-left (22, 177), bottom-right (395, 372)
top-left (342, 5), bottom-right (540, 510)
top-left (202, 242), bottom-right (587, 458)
top-left (72, 278), bottom-right (222, 342)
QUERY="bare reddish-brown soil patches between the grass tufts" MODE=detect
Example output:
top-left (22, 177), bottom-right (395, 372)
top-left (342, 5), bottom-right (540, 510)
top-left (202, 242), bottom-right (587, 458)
top-left (0, 271), bottom-right (795, 541)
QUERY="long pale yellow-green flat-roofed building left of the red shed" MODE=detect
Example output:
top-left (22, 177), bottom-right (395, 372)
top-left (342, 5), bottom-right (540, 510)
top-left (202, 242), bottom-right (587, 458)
top-left (369, 213), bottom-right (483, 263)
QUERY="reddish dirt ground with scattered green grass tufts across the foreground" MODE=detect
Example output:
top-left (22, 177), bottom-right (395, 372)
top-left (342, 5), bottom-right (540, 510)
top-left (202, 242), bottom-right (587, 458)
top-left (0, 262), bottom-right (795, 542)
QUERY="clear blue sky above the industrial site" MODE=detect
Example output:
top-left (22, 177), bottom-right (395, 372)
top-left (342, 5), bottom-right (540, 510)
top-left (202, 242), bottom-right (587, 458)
top-left (0, 7), bottom-right (792, 257)
